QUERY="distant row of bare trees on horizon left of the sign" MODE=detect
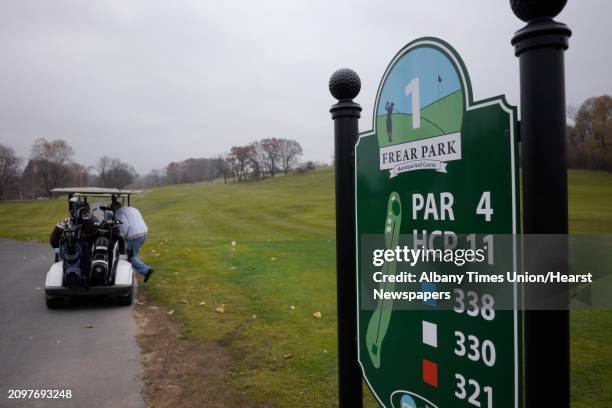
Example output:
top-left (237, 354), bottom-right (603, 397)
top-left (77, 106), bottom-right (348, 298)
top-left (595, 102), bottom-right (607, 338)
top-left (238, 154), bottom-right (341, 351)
top-left (0, 138), bottom-right (315, 200)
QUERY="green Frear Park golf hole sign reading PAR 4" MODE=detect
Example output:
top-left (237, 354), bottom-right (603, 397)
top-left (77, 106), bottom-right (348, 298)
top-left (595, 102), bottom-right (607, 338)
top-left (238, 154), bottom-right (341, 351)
top-left (355, 38), bottom-right (522, 408)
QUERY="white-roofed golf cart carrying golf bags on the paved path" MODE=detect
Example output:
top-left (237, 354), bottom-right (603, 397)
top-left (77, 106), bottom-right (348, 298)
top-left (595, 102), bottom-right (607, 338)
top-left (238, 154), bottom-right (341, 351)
top-left (45, 187), bottom-right (137, 308)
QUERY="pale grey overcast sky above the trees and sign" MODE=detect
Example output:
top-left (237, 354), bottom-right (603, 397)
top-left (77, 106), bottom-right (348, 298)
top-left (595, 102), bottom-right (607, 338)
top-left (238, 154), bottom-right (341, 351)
top-left (0, 0), bottom-right (612, 173)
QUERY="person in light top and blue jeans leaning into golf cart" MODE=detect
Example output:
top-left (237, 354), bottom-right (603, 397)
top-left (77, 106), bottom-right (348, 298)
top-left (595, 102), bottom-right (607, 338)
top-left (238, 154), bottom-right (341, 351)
top-left (112, 202), bottom-right (153, 282)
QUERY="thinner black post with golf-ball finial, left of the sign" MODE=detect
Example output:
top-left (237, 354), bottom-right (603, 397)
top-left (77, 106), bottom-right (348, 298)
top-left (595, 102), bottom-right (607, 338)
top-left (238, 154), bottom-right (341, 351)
top-left (329, 68), bottom-right (363, 408)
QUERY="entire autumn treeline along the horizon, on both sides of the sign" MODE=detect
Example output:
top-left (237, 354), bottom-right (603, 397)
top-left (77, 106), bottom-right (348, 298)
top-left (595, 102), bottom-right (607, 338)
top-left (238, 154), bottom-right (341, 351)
top-left (0, 95), bottom-right (612, 200)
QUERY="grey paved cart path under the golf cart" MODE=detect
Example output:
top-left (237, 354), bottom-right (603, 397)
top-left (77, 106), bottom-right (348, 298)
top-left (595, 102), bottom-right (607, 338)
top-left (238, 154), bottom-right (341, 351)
top-left (0, 239), bottom-right (145, 408)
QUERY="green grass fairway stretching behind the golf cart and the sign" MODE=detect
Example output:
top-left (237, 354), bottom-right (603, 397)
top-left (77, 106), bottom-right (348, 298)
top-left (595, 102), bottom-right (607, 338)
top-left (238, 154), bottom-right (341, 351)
top-left (0, 169), bottom-right (612, 408)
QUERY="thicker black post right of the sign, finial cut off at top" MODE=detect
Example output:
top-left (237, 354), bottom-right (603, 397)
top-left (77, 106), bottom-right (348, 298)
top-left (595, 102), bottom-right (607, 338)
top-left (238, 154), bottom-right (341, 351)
top-left (510, 0), bottom-right (571, 408)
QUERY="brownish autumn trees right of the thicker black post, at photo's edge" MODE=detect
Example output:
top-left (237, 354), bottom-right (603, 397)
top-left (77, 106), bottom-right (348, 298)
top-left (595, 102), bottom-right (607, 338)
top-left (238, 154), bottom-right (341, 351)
top-left (567, 95), bottom-right (612, 171)
